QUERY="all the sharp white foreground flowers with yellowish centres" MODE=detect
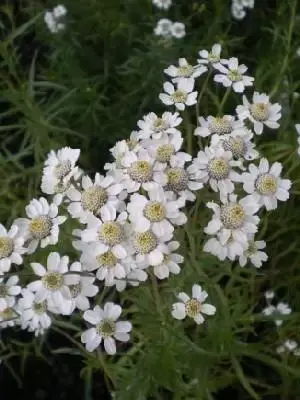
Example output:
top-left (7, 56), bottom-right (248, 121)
top-left (0, 44), bottom-right (291, 354)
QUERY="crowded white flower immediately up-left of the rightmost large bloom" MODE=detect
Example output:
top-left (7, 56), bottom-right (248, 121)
top-left (210, 128), bottom-right (259, 161)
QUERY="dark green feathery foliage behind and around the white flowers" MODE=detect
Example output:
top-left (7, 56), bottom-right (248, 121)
top-left (0, 0), bottom-right (300, 400)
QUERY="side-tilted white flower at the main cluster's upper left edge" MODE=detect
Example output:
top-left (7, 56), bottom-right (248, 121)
top-left (41, 147), bottom-right (81, 201)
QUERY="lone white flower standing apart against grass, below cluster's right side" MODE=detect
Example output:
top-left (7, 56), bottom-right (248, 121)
top-left (172, 285), bottom-right (216, 324)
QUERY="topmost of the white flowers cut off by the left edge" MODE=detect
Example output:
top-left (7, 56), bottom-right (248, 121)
top-left (0, 224), bottom-right (27, 275)
